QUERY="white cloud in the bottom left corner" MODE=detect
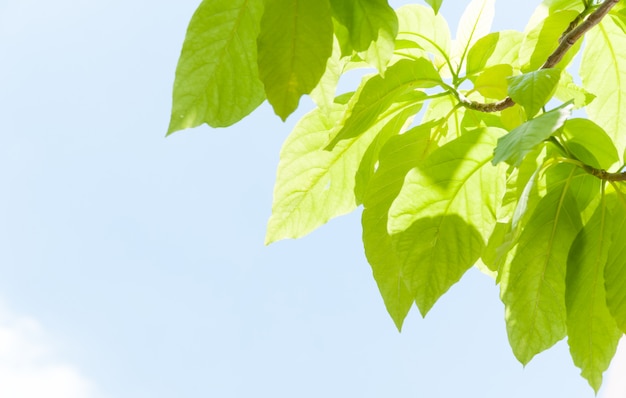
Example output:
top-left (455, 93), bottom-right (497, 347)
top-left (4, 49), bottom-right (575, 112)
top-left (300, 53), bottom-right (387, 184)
top-left (0, 304), bottom-right (96, 398)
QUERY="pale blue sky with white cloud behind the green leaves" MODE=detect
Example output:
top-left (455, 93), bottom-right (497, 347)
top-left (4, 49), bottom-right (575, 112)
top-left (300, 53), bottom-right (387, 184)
top-left (0, 0), bottom-right (620, 398)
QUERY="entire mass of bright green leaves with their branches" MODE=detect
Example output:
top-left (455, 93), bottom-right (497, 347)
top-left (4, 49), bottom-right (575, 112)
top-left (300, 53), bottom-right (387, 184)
top-left (168, 0), bottom-right (626, 391)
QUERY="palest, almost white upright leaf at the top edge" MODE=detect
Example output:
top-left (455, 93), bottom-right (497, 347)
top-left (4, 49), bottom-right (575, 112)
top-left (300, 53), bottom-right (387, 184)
top-left (454, 0), bottom-right (495, 74)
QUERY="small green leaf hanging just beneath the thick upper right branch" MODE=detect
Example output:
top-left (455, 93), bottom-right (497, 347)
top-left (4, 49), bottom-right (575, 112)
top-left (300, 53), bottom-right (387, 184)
top-left (508, 68), bottom-right (561, 118)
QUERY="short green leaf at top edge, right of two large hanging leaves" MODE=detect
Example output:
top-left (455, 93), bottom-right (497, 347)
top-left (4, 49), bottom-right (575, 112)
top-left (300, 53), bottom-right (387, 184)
top-left (330, 0), bottom-right (398, 72)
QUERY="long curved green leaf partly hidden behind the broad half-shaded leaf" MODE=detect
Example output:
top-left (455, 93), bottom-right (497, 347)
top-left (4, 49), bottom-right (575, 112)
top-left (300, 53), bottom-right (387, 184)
top-left (362, 123), bottom-right (436, 330)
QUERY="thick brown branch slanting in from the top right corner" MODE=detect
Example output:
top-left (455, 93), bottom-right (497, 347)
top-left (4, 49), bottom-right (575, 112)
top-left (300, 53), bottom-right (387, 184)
top-left (458, 0), bottom-right (626, 112)
